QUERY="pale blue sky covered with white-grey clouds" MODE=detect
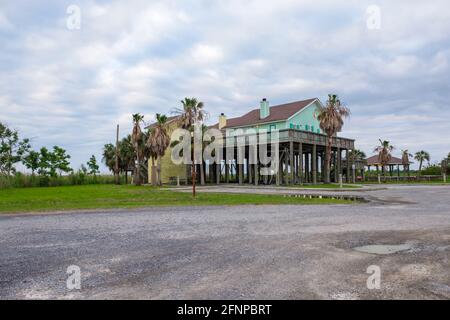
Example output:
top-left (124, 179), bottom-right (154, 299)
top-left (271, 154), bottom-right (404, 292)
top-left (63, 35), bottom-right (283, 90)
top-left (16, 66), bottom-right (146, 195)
top-left (0, 0), bottom-right (450, 168)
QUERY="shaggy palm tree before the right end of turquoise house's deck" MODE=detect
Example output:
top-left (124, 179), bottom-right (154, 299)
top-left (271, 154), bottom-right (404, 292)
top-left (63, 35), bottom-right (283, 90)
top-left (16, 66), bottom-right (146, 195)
top-left (317, 94), bottom-right (350, 183)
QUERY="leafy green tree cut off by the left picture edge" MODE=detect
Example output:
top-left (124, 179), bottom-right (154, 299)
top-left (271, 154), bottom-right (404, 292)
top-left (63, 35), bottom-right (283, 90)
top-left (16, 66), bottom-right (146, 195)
top-left (0, 122), bottom-right (31, 176)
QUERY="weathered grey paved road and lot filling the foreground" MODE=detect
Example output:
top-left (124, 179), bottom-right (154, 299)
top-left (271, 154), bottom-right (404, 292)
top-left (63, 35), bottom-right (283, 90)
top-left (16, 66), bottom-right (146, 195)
top-left (0, 186), bottom-right (450, 299)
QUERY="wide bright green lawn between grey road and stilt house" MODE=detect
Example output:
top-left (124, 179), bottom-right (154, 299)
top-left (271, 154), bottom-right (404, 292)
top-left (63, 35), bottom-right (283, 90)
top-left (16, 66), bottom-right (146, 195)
top-left (0, 185), bottom-right (352, 213)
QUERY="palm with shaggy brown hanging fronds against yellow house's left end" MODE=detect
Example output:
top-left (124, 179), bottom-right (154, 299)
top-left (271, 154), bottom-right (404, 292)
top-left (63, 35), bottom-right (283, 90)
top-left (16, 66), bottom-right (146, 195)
top-left (147, 113), bottom-right (170, 185)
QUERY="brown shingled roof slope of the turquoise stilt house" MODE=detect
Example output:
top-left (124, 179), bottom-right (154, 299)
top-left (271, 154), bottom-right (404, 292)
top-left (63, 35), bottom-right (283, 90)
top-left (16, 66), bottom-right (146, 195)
top-left (221, 98), bottom-right (317, 128)
